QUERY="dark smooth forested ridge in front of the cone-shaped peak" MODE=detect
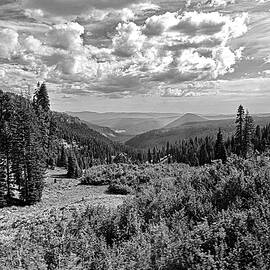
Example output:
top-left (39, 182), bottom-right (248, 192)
top-left (126, 116), bottom-right (270, 149)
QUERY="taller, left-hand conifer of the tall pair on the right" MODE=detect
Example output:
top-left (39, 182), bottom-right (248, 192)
top-left (235, 105), bottom-right (245, 156)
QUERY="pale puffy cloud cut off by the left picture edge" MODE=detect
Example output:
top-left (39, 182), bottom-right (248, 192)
top-left (0, 29), bottom-right (19, 58)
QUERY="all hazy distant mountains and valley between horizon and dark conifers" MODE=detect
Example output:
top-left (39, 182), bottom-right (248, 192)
top-left (68, 111), bottom-right (270, 148)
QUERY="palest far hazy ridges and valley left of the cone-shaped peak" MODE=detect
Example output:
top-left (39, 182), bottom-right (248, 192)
top-left (68, 111), bottom-right (179, 135)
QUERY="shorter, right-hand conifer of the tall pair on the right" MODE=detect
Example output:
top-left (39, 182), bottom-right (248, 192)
top-left (243, 111), bottom-right (254, 157)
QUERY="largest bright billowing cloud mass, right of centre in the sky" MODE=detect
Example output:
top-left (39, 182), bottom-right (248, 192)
top-left (108, 9), bottom-right (247, 83)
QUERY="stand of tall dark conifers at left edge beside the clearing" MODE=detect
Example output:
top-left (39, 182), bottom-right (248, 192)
top-left (0, 84), bottom-right (50, 207)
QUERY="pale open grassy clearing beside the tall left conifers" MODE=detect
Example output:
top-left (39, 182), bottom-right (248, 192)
top-left (0, 168), bottom-right (125, 242)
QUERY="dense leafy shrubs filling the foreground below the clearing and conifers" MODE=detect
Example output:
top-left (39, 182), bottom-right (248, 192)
top-left (0, 155), bottom-right (270, 270)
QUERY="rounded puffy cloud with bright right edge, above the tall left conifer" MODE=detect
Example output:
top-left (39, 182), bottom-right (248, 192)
top-left (47, 22), bottom-right (84, 50)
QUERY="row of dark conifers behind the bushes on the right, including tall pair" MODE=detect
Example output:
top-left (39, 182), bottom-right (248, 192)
top-left (146, 105), bottom-right (270, 166)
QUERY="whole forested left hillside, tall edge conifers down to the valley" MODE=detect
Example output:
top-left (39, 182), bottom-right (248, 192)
top-left (0, 84), bottom-right (135, 207)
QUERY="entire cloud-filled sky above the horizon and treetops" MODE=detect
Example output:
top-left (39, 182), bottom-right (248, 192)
top-left (0, 0), bottom-right (270, 113)
